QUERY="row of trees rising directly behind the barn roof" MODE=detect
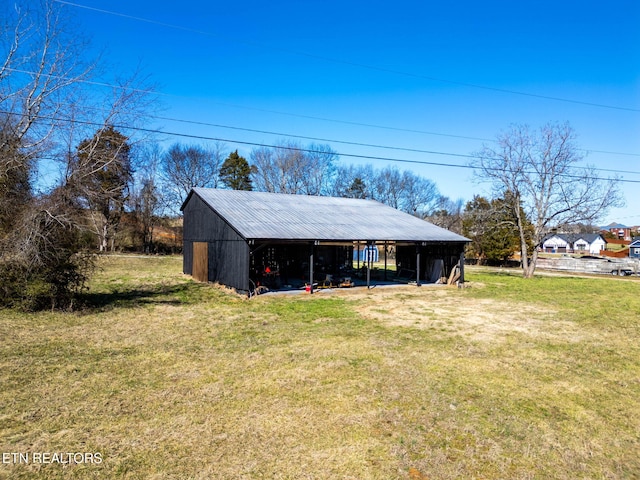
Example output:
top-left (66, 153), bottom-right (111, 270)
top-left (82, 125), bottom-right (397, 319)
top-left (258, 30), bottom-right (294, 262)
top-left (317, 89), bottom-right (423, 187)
top-left (129, 135), bottom-right (462, 246)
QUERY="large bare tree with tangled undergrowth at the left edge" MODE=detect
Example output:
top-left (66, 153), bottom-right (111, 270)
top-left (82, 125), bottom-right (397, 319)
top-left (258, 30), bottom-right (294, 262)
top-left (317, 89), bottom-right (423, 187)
top-left (0, 0), bottom-right (155, 308)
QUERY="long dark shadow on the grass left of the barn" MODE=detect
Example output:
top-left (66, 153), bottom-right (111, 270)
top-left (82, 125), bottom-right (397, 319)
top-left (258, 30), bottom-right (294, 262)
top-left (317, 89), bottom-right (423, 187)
top-left (80, 283), bottom-right (204, 310)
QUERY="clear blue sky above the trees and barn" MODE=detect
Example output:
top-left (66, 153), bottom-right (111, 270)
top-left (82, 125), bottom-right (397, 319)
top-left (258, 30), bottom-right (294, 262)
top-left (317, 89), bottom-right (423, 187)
top-left (57, 0), bottom-right (640, 225)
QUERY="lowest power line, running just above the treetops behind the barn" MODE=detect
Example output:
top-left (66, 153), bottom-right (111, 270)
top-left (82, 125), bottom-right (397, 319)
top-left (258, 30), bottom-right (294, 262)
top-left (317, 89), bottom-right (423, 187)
top-left (5, 111), bottom-right (640, 184)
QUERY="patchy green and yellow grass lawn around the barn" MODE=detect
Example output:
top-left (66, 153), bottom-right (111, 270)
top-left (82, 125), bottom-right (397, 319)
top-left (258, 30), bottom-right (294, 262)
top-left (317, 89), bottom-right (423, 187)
top-left (0, 257), bottom-right (640, 480)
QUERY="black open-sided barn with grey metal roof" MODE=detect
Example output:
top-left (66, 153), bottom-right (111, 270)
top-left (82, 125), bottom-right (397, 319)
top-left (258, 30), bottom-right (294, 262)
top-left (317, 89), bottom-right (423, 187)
top-left (181, 188), bottom-right (469, 293)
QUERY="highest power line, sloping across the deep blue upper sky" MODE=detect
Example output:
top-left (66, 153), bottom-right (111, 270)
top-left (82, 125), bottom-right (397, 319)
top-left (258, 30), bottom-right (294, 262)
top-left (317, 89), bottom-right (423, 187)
top-left (54, 0), bottom-right (640, 112)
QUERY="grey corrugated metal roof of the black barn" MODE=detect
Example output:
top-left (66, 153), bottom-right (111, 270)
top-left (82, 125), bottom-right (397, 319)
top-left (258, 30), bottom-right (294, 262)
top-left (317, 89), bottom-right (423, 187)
top-left (182, 188), bottom-right (469, 242)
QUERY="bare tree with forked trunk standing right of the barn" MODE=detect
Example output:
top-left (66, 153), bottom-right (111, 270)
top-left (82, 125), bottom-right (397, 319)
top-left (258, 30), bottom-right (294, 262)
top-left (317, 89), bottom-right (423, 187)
top-left (473, 124), bottom-right (623, 278)
